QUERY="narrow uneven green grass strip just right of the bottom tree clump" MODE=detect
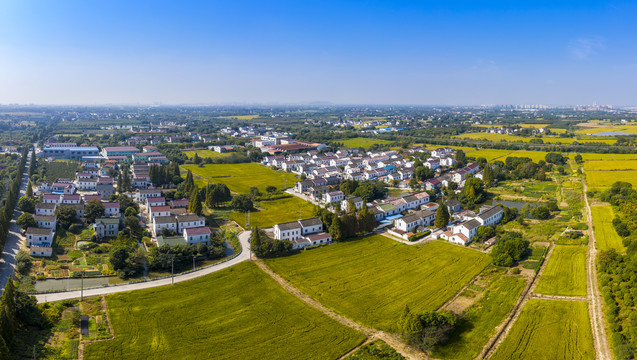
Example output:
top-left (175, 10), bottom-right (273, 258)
top-left (433, 275), bottom-right (525, 360)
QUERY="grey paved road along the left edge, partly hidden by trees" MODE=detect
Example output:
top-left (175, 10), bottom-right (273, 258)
top-left (0, 151), bottom-right (31, 291)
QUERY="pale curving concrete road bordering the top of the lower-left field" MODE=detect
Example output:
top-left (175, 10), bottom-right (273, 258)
top-left (35, 231), bottom-right (252, 303)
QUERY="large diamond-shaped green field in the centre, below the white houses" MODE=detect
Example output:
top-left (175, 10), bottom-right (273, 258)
top-left (266, 235), bottom-right (490, 331)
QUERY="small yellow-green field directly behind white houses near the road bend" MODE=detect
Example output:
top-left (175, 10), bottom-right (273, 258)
top-left (230, 196), bottom-right (314, 228)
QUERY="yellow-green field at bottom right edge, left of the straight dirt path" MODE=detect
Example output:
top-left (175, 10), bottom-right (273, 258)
top-left (491, 299), bottom-right (595, 360)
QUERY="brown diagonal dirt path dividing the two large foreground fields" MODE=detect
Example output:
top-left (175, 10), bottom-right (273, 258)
top-left (255, 260), bottom-right (429, 360)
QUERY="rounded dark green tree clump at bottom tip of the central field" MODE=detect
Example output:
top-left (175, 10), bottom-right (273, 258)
top-left (397, 306), bottom-right (458, 351)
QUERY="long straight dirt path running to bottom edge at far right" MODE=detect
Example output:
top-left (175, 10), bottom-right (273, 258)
top-left (582, 168), bottom-right (613, 360)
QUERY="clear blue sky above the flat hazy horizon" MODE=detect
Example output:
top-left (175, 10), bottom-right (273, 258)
top-left (0, 0), bottom-right (637, 105)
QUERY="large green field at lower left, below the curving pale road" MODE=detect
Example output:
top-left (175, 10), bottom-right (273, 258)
top-left (84, 262), bottom-right (365, 360)
